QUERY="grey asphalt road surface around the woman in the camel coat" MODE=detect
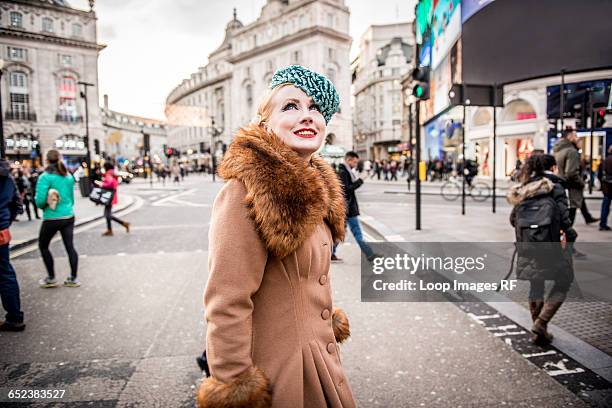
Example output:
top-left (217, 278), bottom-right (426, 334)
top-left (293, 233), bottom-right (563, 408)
top-left (0, 176), bottom-right (611, 408)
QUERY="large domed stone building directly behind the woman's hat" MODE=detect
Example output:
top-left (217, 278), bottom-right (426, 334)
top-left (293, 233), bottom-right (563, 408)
top-left (166, 0), bottom-right (352, 159)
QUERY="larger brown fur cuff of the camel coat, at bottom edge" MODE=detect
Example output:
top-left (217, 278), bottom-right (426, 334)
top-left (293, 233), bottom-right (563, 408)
top-left (197, 367), bottom-right (272, 408)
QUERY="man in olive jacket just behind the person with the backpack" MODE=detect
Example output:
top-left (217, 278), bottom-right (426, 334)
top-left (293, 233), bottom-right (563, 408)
top-left (553, 128), bottom-right (584, 225)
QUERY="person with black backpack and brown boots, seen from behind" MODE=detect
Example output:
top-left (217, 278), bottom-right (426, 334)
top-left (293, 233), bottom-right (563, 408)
top-left (507, 154), bottom-right (578, 345)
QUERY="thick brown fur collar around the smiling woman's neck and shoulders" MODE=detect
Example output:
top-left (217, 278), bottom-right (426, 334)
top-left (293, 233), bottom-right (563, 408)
top-left (219, 125), bottom-right (346, 258)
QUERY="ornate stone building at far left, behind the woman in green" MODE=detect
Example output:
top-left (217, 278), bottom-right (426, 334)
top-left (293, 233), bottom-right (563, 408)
top-left (0, 0), bottom-right (104, 166)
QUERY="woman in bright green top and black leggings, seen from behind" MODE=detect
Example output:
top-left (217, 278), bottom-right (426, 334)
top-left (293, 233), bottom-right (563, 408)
top-left (34, 150), bottom-right (80, 288)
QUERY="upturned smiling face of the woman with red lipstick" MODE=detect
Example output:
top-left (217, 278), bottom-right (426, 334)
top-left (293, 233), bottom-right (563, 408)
top-left (265, 86), bottom-right (326, 159)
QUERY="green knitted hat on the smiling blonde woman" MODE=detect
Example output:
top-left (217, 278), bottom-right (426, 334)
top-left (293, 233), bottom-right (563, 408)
top-left (270, 65), bottom-right (340, 123)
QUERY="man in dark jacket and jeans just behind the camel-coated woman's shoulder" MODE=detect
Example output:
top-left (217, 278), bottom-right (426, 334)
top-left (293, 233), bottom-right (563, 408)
top-left (331, 151), bottom-right (377, 262)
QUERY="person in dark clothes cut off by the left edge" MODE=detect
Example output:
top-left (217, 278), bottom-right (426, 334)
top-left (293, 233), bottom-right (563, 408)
top-left (0, 160), bottom-right (25, 331)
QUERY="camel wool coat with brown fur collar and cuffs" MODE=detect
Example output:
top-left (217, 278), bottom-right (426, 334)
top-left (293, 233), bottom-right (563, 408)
top-left (198, 126), bottom-right (355, 408)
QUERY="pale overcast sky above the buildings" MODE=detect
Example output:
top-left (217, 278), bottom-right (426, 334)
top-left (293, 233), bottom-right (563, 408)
top-left (69, 0), bottom-right (415, 119)
